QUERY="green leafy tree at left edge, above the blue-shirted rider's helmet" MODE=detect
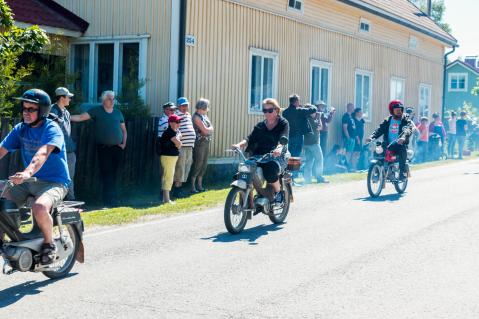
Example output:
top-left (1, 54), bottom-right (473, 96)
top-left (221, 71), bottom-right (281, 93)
top-left (0, 0), bottom-right (50, 116)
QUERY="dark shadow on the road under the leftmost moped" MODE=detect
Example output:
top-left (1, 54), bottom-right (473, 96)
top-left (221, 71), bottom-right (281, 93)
top-left (0, 273), bottom-right (77, 309)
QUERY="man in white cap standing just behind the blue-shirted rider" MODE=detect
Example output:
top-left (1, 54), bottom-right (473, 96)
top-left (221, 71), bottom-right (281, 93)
top-left (50, 87), bottom-right (76, 200)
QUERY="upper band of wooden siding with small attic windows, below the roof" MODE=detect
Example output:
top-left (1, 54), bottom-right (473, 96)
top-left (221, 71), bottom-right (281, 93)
top-left (228, 0), bottom-right (444, 59)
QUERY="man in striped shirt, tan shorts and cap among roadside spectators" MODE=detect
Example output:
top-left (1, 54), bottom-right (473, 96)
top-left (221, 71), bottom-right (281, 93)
top-left (172, 97), bottom-right (196, 198)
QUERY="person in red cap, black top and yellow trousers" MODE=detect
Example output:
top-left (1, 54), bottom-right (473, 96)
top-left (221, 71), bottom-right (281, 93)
top-left (160, 114), bottom-right (182, 204)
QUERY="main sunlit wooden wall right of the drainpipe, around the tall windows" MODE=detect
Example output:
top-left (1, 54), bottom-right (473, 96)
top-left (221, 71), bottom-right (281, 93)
top-left (185, 0), bottom-right (442, 157)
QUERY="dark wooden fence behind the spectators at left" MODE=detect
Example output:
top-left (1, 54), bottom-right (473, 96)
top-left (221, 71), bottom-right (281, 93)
top-left (0, 118), bottom-right (160, 200)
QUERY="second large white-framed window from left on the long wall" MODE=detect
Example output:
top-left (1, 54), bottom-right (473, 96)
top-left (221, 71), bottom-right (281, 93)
top-left (311, 60), bottom-right (331, 105)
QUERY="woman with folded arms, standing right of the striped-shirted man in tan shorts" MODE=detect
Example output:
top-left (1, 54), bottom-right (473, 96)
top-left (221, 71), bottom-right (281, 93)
top-left (191, 98), bottom-right (214, 193)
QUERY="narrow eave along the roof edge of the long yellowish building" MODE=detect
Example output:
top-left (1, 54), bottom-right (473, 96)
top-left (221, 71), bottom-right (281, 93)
top-left (339, 0), bottom-right (457, 47)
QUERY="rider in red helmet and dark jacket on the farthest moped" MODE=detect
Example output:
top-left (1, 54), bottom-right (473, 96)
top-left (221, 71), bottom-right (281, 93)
top-left (366, 100), bottom-right (414, 180)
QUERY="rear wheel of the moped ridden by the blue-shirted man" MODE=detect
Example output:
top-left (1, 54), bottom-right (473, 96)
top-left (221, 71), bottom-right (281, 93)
top-left (43, 225), bottom-right (80, 279)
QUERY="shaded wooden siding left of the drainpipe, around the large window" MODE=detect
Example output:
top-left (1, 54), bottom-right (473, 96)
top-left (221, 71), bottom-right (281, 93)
top-left (57, 0), bottom-right (171, 114)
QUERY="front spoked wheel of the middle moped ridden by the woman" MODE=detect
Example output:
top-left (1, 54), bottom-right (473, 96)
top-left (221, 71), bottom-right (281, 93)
top-left (224, 187), bottom-right (247, 234)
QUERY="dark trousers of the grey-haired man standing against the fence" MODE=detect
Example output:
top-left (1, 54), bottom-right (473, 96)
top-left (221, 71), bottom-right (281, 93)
top-left (97, 144), bottom-right (123, 206)
